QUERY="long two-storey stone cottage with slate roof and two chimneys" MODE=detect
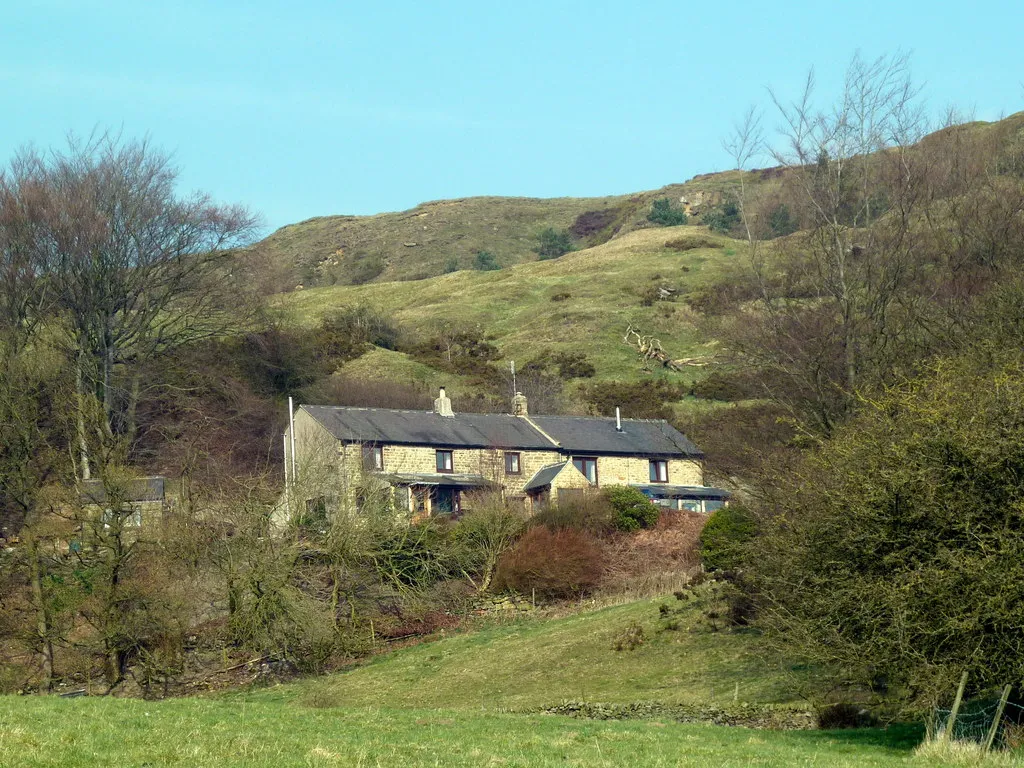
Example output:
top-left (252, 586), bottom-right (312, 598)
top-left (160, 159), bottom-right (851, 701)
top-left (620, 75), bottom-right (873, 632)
top-left (285, 388), bottom-right (727, 518)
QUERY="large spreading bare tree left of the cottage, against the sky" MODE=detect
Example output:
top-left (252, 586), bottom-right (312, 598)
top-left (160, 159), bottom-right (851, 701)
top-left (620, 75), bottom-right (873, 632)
top-left (0, 134), bottom-right (256, 477)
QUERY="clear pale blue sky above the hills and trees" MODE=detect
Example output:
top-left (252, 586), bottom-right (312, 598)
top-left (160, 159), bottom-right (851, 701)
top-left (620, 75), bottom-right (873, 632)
top-left (0, 0), bottom-right (1024, 229)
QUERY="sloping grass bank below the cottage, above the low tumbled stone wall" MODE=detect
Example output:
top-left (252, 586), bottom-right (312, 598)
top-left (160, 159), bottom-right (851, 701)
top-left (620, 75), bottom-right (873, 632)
top-left (251, 596), bottom-right (806, 712)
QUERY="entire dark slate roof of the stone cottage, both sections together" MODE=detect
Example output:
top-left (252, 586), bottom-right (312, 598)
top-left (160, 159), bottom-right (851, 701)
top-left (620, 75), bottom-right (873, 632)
top-left (301, 406), bottom-right (703, 459)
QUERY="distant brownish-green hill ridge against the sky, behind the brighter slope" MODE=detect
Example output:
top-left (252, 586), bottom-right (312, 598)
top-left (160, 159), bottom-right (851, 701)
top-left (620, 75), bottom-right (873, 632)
top-left (246, 174), bottom-right (749, 291)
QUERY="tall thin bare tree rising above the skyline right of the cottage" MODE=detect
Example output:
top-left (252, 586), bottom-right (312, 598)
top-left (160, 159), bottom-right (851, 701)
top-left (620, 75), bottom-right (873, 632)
top-left (725, 54), bottom-right (927, 433)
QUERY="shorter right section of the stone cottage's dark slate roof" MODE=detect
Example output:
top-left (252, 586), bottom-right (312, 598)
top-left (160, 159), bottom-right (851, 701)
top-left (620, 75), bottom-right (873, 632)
top-left (529, 416), bottom-right (703, 459)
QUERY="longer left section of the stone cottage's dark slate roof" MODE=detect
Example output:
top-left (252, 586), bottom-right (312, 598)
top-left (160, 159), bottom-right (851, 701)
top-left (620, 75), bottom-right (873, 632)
top-left (301, 406), bottom-right (555, 451)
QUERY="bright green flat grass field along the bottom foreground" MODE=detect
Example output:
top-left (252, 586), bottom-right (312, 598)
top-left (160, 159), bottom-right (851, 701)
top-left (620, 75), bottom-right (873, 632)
top-left (0, 696), bottom-right (941, 768)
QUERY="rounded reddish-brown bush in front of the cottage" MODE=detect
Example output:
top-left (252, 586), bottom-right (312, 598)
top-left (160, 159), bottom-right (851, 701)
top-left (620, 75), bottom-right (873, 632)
top-left (496, 525), bottom-right (603, 598)
